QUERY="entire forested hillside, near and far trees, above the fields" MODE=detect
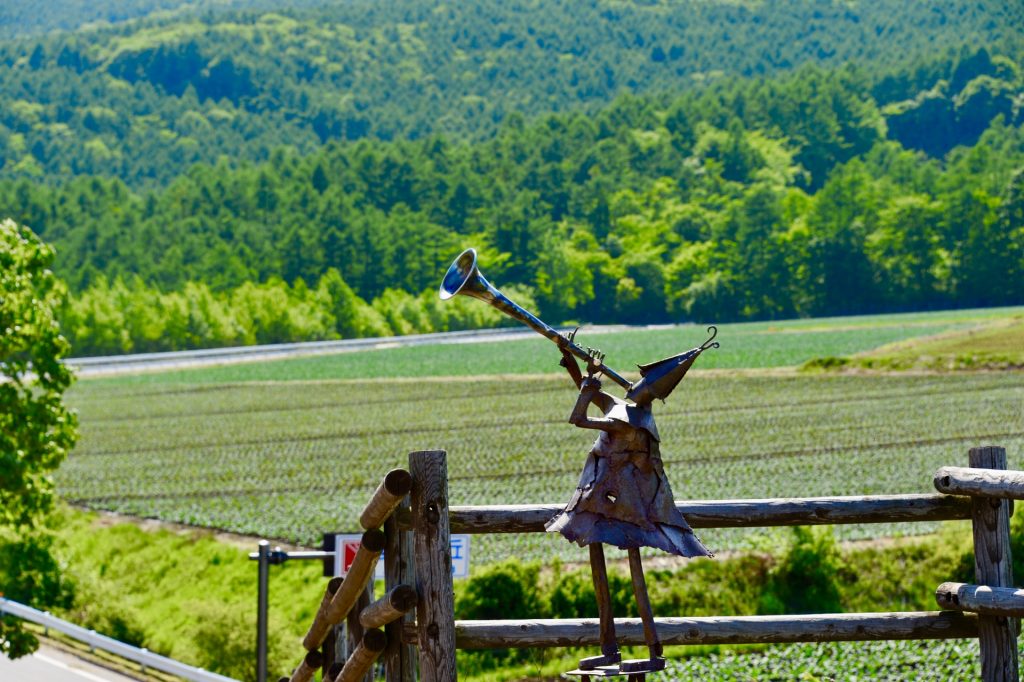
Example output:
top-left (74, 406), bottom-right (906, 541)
top-left (0, 0), bottom-right (1024, 354)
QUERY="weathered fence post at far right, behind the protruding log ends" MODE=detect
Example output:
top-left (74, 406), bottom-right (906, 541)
top-left (970, 446), bottom-right (1017, 682)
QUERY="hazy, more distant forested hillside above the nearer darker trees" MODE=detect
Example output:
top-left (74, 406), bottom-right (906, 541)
top-left (0, 0), bottom-right (1024, 187)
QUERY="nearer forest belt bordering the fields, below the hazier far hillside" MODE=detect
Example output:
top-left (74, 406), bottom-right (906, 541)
top-left (0, 49), bottom-right (1024, 352)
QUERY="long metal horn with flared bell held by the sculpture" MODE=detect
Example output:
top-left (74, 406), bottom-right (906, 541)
top-left (439, 249), bottom-right (633, 391)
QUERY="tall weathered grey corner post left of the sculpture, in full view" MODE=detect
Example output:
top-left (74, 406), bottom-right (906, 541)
top-left (409, 451), bottom-right (456, 682)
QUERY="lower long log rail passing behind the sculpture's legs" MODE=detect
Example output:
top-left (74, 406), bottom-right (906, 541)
top-left (402, 611), bottom-right (978, 649)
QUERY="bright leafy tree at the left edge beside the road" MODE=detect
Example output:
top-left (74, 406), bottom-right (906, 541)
top-left (0, 220), bottom-right (76, 657)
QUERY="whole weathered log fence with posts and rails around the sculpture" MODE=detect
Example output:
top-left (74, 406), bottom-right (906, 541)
top-left (282, 446), bottom-right (1024, 682)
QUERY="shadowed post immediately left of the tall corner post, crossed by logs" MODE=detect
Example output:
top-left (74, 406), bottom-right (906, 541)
top-left (384, 497), bottom-right (416, 682)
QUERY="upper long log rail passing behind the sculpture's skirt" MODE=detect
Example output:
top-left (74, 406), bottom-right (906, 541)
top-left (396, 495), bottom-right (971, 534)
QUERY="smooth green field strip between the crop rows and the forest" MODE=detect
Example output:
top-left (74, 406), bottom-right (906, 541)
top-left (83, 308), bottom-right (1024, 386)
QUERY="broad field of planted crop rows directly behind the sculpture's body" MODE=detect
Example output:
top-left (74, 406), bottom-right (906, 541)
top-left (64, 373), bottom-right (1024, 560)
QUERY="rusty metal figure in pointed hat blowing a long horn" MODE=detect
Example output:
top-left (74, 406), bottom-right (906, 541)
top-left (440, 249), bottom-right (719, 678)
